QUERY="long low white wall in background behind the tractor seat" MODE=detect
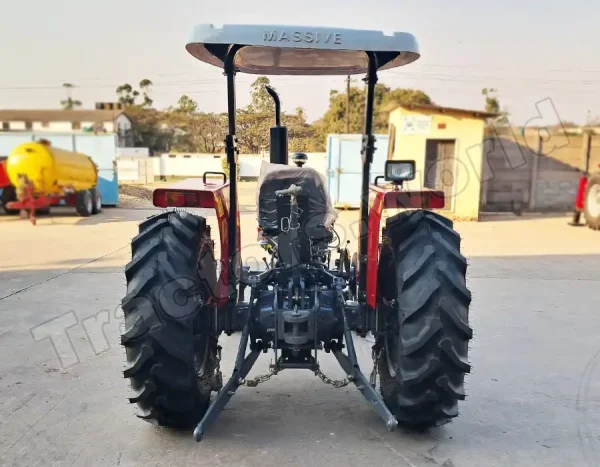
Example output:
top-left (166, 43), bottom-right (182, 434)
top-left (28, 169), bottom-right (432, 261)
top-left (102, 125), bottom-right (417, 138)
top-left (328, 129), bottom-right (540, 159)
top-left (117, 153), bottom-right (327, 183)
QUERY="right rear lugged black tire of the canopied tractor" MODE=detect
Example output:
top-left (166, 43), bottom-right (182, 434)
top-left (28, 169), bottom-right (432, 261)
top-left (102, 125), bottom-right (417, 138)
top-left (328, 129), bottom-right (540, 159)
top-left (378, 211), bottom-right (473, 430)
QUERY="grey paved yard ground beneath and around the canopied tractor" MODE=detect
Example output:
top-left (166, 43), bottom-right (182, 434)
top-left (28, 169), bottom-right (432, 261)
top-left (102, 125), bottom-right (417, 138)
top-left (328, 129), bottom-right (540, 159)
top-left (0, 209), bottom-right (600, 467)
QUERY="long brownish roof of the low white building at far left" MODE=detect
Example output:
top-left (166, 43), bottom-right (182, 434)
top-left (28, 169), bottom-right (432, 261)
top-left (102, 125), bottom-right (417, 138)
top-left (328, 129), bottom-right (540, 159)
top-left (0, 109), bottom-right (125, 122)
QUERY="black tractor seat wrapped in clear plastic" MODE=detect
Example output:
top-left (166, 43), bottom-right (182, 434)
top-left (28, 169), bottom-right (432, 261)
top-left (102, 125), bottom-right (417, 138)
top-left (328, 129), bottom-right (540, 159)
top-left (258, 166), bottom-right (336, 243)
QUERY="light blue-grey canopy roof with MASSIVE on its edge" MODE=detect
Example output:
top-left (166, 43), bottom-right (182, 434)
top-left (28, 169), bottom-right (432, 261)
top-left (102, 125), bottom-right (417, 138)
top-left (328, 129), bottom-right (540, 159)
top-left (186, 24), bottom-right (419, 75)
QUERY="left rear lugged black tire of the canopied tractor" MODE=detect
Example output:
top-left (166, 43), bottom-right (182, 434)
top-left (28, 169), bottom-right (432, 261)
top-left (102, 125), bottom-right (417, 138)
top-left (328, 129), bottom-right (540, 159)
top-left (121, 212), bottom-right (218, 428)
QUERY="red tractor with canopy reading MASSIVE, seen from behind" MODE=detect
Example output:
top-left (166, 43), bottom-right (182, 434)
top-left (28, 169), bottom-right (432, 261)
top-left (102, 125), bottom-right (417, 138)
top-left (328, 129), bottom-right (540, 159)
top-left (121, 25), bottom-right (473, 441)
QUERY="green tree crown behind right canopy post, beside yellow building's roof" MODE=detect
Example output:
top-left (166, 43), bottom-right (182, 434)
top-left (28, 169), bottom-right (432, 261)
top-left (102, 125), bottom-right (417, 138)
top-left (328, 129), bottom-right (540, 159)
top-left (318, 84), bottom-right (433, 138)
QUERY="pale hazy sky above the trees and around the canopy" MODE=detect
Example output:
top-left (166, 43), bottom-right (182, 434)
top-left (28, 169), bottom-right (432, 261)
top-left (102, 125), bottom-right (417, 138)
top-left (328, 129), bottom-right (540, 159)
top-left (0, 0), bottom-right (600, 125)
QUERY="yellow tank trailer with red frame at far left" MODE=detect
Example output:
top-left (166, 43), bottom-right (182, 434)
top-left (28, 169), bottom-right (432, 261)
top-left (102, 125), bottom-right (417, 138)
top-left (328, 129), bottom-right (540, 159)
top-left (6, 140), bottom-right (102, 220)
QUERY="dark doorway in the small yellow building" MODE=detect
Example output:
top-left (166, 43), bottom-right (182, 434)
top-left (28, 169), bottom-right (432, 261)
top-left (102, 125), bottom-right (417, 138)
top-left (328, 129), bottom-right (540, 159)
top-left (425, 139), bottom-right (455, 209)
